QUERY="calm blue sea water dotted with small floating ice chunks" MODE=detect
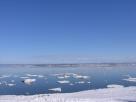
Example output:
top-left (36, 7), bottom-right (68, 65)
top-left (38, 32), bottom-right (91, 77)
top-left (0, 64), bottom-right (136, 95)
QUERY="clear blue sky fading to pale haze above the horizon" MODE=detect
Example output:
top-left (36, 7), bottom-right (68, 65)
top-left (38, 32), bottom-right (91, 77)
top-left (0, 0), bottom-right (136, 64)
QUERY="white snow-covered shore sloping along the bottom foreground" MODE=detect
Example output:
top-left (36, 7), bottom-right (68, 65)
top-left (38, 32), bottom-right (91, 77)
top-left (0, 85), bottom-right (136, 102)
